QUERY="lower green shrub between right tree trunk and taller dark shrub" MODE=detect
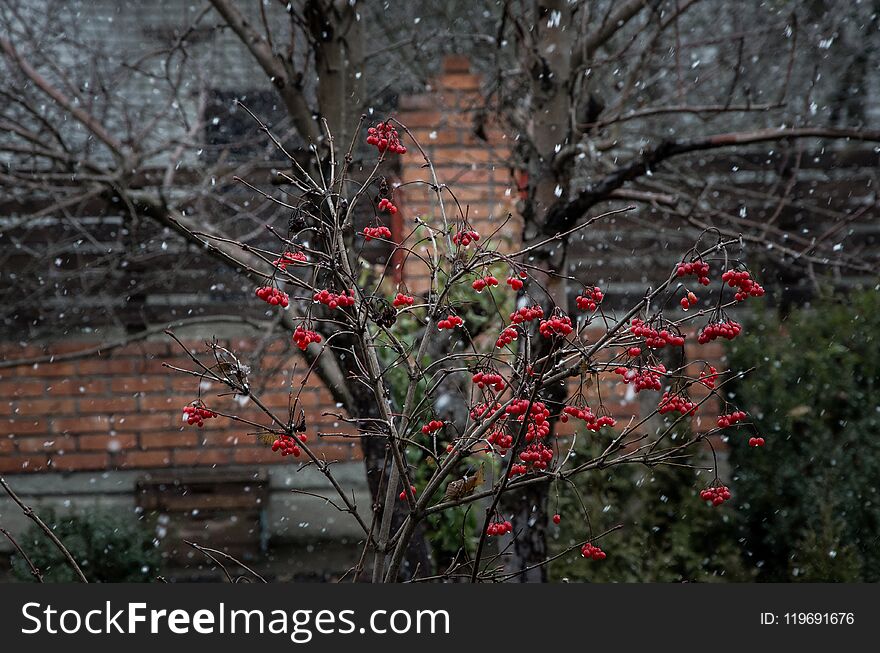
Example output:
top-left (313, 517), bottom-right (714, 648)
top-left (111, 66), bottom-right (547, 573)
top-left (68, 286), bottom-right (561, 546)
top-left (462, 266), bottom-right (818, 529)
top-left (550, 438), bottom-right (749, 582)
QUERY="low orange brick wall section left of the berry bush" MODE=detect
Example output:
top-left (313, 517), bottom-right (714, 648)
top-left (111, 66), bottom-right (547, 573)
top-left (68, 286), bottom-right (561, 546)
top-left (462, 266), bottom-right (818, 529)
top-left (0, 335), bottom-right (359, 474)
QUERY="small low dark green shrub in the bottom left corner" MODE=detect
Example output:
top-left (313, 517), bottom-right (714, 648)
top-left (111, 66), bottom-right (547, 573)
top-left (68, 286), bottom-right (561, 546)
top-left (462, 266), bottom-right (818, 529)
top-left (12, 510), bottom-right (161, 583)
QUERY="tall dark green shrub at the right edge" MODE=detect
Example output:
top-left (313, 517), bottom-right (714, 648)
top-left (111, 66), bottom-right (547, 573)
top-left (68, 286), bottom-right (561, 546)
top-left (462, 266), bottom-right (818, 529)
top-left (730, 289), bottom-right (880, 582)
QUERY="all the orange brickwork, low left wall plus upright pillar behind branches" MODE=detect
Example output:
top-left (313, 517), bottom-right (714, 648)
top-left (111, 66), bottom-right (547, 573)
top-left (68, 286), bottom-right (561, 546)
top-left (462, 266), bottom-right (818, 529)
top-left (0, 56), bottom-right (722, 474)
